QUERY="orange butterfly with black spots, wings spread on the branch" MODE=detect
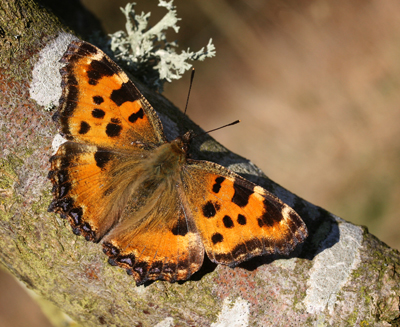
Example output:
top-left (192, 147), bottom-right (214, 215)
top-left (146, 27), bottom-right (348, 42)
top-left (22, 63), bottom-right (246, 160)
top-left (48, 41), bottom-right (308, 285)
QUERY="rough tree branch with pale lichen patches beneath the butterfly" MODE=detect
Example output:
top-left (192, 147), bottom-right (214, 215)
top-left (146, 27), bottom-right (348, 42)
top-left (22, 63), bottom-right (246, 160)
top-left (0, 0), bottom-right (400, 326)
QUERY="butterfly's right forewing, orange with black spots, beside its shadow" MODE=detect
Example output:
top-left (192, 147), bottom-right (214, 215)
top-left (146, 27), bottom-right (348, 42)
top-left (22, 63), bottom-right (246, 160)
top-left (182, 159), bottom-right (308, 266)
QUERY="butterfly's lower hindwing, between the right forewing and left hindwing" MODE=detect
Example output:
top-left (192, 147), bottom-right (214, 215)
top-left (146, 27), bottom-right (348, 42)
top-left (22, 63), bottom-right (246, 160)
top-left (103, 180), bottom-right (204, 285)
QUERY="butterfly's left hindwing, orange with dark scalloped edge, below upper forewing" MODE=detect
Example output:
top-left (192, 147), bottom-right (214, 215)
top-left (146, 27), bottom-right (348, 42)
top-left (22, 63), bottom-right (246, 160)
top-left (49, 142), bottom-right (141, 241)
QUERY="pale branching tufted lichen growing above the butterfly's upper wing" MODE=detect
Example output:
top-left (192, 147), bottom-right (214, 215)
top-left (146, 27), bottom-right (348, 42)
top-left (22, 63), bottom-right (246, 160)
top-left (110, 0), bottom-right (215, 92)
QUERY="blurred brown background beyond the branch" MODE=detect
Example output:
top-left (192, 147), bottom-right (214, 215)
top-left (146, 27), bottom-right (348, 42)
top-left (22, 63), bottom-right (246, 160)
top-left (0, 0), bottom-right (400, 326)
